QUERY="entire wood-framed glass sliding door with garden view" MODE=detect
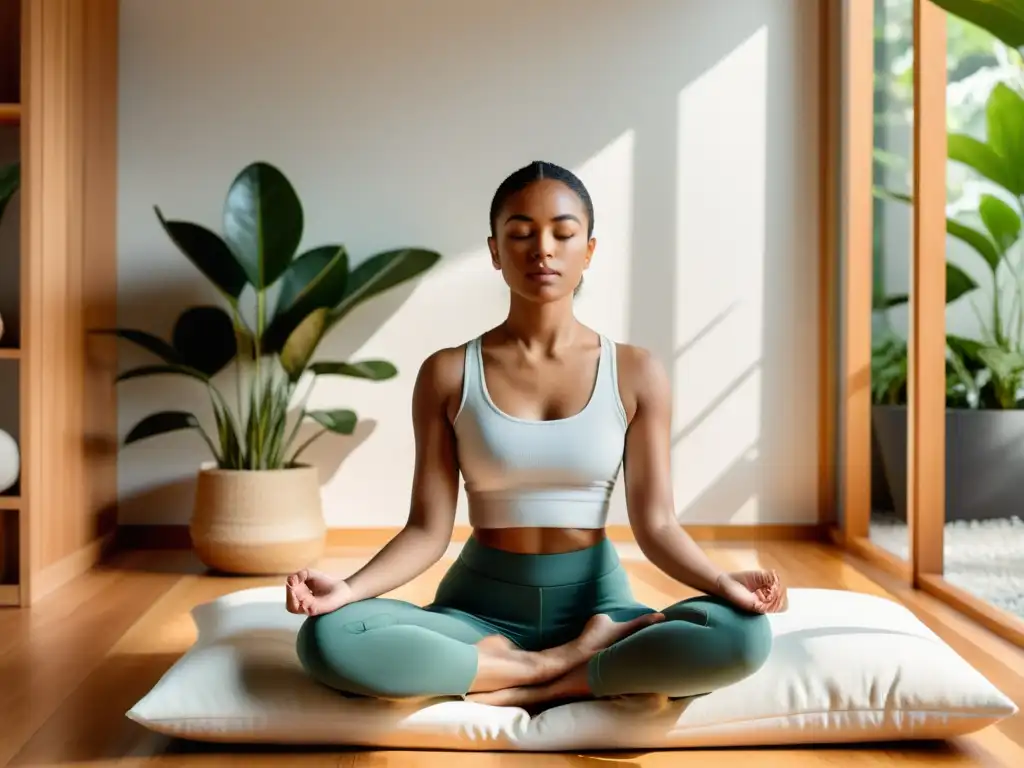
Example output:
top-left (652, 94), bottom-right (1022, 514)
top-left (825, 0), bottom-right (1024, 646)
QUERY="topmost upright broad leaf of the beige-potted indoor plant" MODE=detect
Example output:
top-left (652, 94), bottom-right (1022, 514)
top-left (224, 162), bottom-right (303, 291)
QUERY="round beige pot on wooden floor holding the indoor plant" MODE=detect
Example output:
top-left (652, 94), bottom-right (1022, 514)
top-left (189, 466), bottom-right (327, 575)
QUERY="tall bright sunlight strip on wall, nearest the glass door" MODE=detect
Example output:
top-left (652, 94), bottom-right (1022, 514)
top-left (673, 27), bottom-right (768, 522)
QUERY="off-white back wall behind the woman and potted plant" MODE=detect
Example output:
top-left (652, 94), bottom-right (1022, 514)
top-left (119, 0), bottom-right (817, 526)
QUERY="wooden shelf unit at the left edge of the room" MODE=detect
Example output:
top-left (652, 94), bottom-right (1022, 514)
top-left (0, 0), bottom-right (119, 607)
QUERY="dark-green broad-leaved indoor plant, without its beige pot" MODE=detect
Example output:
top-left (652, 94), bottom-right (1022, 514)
top-left (102, 162), bottom-right (440, 470)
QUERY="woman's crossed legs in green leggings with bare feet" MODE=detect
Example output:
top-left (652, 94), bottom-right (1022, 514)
top-left (298, 597), bottom-right (771, 706)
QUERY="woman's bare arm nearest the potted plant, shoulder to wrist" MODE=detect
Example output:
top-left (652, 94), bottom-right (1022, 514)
top-left (344, 349), bottom-right (462, 602)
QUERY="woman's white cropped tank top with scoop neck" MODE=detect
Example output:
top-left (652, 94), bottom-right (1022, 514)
top-left (454, 336), bottom-right (627, 528)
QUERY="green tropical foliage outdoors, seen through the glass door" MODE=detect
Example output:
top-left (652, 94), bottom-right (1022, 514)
top-left (872, 0), bottom-right (1024, 409)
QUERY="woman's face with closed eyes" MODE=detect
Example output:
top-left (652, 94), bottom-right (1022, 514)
top-left (487, 179), bottom-right (597, 302)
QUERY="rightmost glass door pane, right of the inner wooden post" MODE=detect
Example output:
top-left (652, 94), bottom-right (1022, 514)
top-left (922, 0), bottom-right (1024, 634)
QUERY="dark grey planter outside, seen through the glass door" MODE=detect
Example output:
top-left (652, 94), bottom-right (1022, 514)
top-left (871, 406), bottom-right (1024, 521)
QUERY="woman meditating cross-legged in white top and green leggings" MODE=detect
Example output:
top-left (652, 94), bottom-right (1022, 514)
top-left (286, 162), bottom-right (785, 706)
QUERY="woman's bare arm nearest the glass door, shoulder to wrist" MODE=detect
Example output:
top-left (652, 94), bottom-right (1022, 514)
top-left (620, 347), bottom-right (725, 596)
